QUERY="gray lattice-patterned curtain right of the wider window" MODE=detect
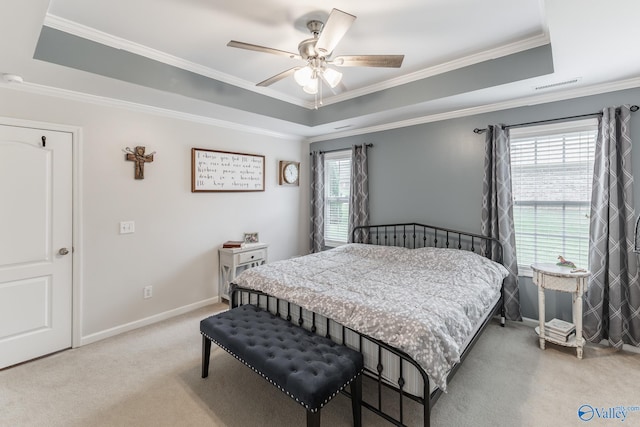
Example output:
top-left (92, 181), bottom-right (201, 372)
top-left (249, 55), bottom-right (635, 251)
top-left (583, 105), bottom-right (640, 348)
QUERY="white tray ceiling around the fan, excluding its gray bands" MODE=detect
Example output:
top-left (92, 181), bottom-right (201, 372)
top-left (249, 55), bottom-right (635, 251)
top-left (0, 0), bottom-right (640, 140)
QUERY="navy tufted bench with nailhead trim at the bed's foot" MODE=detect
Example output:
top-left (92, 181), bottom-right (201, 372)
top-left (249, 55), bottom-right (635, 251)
top-left (200, 304), bottom-right (364, 427)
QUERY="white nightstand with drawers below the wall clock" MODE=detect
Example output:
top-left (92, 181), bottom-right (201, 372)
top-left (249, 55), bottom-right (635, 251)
top-left (218, 243), bottom-right (269, 300)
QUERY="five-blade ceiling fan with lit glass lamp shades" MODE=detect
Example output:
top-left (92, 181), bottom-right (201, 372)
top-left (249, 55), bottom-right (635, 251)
top-left (227, 9), bottom-right (404, 95)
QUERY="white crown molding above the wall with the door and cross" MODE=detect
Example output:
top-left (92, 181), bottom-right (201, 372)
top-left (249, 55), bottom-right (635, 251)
top-left (0, 82), bottom-right (302, 140)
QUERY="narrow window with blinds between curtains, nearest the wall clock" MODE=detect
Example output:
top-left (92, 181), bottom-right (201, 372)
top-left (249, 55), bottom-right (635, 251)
top-left (324, 150), bottom-right (351, 247)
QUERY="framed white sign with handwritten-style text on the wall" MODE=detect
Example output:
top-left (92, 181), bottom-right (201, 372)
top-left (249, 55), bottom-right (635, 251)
top-left (191, 148), bottom-right (265, 193)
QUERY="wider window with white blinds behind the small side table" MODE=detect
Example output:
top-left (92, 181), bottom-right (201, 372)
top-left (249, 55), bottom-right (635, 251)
top-left (510, 119), bottom-right (598, 275)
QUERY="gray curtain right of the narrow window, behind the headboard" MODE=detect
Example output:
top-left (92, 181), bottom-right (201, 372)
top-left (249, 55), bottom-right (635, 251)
top-left (348, 144), bottom-right (369, 242)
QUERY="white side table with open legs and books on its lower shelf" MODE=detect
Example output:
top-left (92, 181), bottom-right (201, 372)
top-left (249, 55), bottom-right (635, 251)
top-left (531, 264), bottom-right (589, 359)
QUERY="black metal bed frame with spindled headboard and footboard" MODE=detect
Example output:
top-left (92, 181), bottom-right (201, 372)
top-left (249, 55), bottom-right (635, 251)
top-left (229, 223), bottom-right (505, 427)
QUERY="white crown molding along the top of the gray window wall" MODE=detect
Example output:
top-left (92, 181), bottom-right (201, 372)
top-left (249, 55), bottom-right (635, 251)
top-left (305, 77), bottom-right (640, 143)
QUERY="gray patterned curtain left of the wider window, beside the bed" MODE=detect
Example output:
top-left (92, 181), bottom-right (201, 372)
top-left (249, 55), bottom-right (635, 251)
top-left (482, 125), bottom-right (522, 320)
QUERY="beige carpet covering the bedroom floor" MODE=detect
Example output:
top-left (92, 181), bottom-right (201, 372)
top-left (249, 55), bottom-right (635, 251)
top-left (0, 305), bottom-right (640, 427)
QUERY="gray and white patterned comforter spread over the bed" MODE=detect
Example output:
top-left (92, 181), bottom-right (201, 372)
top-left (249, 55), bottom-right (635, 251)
top-left (234, 244), bottom-right (508, 390)
